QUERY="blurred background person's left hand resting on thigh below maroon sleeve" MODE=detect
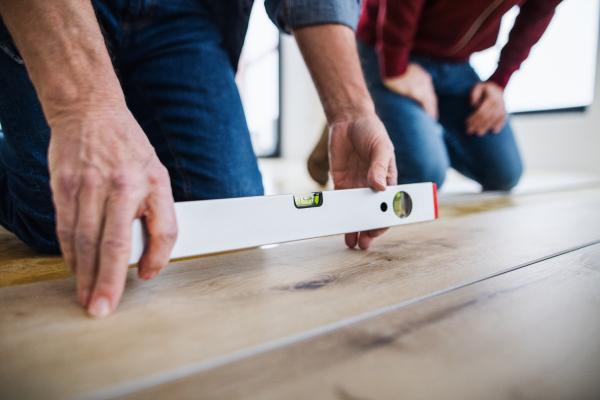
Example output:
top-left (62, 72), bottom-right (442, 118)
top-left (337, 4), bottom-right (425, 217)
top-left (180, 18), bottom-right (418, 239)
top-left (383, 63), bottom-right (438, 119)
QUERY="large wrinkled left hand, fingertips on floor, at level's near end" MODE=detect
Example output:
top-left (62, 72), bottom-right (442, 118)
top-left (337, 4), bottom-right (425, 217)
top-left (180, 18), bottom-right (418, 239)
top-left (48, 104), bottom-right (177, 317)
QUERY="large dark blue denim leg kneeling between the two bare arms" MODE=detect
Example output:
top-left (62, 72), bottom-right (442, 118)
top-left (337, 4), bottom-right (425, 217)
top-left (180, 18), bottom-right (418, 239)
top-left (105, 0), bottom-right (263, 201)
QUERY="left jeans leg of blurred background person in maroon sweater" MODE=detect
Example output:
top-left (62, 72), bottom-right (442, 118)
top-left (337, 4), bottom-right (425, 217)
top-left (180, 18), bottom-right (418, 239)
top-left (358, 41), bottom-right (449, 187)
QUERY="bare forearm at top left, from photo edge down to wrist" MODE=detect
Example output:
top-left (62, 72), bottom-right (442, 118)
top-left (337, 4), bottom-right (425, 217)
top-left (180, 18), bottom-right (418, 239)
top-left (0, 0), bottom-right (123, 118)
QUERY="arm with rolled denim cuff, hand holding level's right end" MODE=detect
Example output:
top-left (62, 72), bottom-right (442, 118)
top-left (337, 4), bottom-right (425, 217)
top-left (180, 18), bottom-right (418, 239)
top-left (265, 0), bottom-right (397, 249)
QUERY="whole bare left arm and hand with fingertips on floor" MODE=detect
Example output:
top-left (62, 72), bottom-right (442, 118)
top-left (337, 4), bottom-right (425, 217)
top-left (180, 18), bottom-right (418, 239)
top-left (0, 0), bottom-right (176, 316)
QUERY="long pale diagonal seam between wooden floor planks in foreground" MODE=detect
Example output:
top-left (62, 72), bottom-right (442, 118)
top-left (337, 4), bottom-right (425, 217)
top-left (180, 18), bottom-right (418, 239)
top-left (72, 239), bottom-right (600, 400)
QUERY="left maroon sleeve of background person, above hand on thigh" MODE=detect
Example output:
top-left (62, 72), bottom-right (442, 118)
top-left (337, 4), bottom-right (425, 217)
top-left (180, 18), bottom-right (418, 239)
top-left (376, 0), bottom-right (425, 78)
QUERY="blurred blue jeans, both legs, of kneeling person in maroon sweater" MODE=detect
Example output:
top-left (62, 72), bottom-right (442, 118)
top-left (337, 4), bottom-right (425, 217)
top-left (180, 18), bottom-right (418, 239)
top-left (358, 41), bottom-right (523, 190)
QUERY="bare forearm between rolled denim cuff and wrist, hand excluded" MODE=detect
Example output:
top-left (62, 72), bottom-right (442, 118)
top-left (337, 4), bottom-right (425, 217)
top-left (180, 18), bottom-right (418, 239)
top-left (294, 24), bottom-right (375, 124)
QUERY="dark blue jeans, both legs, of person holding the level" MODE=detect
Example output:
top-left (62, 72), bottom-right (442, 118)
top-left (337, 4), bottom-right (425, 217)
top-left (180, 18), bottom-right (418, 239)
top-left (0, 0), bottom-right (263, 253)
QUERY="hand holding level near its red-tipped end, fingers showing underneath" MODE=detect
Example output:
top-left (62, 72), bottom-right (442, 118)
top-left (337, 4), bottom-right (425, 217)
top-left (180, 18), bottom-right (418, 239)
top-left (329, 114), bottom-right (398, 250)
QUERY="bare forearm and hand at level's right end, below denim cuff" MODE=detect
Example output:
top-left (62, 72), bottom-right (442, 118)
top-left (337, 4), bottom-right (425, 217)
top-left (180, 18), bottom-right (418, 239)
top-left (294, 24), bottom-right (397, 249)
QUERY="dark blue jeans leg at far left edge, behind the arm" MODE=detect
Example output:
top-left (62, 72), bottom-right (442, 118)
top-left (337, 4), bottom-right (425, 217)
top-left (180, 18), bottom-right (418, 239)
top-left (0, 19), bottom-right (60, 253)
